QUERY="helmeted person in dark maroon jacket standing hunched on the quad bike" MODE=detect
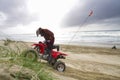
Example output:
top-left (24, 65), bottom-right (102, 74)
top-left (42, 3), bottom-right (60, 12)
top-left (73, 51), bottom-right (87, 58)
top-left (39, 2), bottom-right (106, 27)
top-left (36, 28), bottom-right (55, 60)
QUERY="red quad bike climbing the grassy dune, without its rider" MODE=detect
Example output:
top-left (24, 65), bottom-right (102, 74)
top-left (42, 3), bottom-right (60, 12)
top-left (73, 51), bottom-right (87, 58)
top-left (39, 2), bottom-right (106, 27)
top-left (24, 42), bottom-right (67, 72)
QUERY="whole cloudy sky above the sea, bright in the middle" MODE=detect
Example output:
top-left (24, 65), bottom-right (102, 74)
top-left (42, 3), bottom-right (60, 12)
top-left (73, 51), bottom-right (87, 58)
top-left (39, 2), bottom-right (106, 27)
top-left (0, 0), bottom-right (120, 34)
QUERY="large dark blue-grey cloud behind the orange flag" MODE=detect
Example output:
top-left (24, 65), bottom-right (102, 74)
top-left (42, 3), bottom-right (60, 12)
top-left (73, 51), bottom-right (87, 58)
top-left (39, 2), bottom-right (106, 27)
top-left (64, 0), bottom-right (120, 26)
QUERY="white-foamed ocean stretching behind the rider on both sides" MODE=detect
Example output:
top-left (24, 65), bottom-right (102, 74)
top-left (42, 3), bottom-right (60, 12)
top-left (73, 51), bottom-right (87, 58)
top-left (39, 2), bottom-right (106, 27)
top-left (0, 30), bottom-right (120, 47)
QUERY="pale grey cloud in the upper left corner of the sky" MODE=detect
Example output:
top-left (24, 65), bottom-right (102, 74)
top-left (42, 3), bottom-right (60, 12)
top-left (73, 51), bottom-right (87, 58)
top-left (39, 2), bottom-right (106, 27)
top-left (0, 0), bottom-right (36, 29)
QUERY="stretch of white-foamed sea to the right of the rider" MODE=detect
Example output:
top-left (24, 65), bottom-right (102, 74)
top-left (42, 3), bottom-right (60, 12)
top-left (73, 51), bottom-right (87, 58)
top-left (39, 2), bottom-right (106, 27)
top-left (57, 30), bottom-right (120, 47)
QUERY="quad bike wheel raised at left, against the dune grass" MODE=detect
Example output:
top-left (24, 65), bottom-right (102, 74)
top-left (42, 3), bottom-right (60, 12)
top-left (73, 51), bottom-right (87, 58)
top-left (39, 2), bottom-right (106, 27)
top-left (24, 49), bottom-right (37, 61)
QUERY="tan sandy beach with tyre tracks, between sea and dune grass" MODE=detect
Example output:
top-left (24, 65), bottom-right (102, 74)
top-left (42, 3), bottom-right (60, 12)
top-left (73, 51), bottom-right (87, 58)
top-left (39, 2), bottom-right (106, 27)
top-left (0, 41), bottom-right (120, 80)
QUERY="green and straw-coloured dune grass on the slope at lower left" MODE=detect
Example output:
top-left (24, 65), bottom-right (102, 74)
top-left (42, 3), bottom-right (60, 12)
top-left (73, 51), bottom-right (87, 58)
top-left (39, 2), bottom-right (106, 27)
top-left (0, 40), bottom-right (55, 80)
